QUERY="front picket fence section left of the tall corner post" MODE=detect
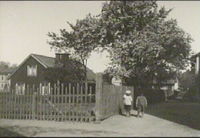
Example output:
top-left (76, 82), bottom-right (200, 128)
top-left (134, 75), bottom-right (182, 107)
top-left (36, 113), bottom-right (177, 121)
top-left (0, 83), bottom-right (95, 122)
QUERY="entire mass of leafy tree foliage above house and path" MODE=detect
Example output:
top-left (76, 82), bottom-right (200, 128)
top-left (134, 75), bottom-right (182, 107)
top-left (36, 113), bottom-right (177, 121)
top-left (48, 0), bottom-right (192, 85)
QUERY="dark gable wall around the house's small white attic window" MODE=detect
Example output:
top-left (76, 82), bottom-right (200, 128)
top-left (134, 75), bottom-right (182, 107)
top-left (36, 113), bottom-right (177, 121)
top-left (10, 57), bottom-right (45, 89)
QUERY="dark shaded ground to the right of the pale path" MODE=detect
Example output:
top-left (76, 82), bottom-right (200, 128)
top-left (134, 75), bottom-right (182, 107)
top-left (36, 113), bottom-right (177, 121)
top-left (146, 100), bottom-right (200, 130)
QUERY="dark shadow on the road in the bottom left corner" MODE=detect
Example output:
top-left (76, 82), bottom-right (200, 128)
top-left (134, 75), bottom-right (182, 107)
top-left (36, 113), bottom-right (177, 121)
top-left (0, 127), bottom-right (25, 137)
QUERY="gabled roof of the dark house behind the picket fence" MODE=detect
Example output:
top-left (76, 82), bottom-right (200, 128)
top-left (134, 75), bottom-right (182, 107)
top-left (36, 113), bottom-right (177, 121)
top-left (9, 54), bottom-right (96, 80)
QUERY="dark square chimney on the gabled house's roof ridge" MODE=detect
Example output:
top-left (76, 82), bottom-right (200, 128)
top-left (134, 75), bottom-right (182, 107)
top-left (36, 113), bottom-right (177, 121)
top-left (55, 53), bottom-right (69, 67)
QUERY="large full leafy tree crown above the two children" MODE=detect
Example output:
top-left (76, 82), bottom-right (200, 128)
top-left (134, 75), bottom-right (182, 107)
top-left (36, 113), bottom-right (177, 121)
top-left (95, 1), bottom-right (191, 85)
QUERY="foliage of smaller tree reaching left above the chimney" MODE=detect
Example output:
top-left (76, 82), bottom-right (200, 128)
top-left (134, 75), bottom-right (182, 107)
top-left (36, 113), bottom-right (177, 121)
top-left (48, 14), bottom-right (99, 65)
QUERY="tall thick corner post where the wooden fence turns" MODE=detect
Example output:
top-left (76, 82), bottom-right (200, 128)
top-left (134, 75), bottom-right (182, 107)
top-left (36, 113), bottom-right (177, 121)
top-left (95, 74), bottom-right (103, 122)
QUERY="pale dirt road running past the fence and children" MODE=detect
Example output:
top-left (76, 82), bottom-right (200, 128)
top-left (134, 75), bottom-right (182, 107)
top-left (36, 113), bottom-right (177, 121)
top-left (0, 100), bottom-right (200, 137)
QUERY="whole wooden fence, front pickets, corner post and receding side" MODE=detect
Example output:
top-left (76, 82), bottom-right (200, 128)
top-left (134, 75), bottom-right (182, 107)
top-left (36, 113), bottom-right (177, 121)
top-left (0, 75), bottom-right (134, 122)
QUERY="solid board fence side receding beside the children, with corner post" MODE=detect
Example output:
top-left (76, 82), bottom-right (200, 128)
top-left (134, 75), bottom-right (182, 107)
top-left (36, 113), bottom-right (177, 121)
top-left (96, 74), bottom-right (134, 121)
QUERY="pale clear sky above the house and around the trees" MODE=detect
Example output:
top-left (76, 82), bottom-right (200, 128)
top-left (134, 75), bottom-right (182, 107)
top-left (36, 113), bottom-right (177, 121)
top-left (0, 1), bottom-right (200, 72)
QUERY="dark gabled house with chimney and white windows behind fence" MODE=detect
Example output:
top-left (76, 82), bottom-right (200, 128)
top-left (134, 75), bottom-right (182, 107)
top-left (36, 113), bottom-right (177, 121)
top-left (9, 53), bottom-right (95, 94)
